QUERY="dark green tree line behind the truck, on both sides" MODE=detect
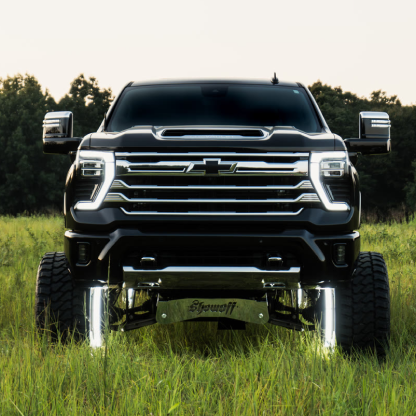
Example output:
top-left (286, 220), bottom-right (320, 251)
top-left (0, 74), bottom-right (416, 218)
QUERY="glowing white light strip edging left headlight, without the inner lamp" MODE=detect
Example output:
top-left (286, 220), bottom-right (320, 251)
top-left (74, 150), bottom-right (115, 211)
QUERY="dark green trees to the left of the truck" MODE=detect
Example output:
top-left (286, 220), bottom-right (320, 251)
top-left (0, 75), bottom-right (112, 215)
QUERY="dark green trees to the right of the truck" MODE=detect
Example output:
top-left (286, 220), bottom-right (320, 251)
top-left (309, 81), bottom-right (416, 211)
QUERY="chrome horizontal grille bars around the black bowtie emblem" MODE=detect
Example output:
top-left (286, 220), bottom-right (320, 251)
top-left (105, 152), bottom-right (320, 216)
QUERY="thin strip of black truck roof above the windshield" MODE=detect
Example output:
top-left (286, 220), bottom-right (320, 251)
top-left (131, 78), bottom-right (302, 87)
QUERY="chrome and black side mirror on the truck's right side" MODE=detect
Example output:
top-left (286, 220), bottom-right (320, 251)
top-left (345, 111), bottom-right (391, 155)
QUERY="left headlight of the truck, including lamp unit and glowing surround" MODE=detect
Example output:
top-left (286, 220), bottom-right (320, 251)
top-left (75, 150), bottom-right (115, 211)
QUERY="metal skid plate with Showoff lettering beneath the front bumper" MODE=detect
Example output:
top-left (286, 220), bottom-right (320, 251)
top-left (156, 298), bottom-right (269, 324)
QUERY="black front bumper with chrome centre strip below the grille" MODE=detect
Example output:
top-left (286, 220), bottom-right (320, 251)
top-left (65, 228), bottom-right (360, 291)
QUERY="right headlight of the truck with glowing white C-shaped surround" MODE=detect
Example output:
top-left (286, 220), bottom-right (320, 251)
top-left (310, 152), bottom-right (350, 211)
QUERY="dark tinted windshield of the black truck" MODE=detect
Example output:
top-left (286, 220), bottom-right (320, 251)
top-left (107, 84), bottom-right (321, 133)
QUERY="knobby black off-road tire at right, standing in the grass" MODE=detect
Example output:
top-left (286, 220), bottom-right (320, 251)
top-left (335, 252), bottom-right (390, 356)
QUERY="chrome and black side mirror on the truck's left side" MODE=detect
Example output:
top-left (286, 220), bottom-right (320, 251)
top-left (42, 111), bottom-right (81, 154)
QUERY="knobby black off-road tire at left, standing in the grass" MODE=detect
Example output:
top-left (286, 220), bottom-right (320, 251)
top-left (35, 252), bottom-right (89, 341)
